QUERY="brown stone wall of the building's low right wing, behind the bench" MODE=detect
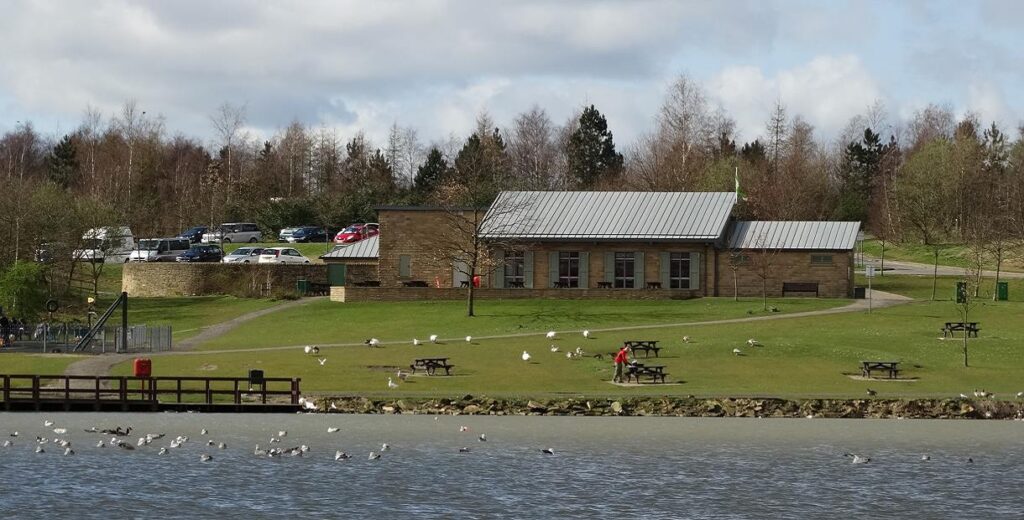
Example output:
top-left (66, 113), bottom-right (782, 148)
top-left (719, 251), bottom-right (853, 298)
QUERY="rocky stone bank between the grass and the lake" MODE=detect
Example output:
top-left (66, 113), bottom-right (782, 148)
top-left (315, 395), bottom-right (1024, 420)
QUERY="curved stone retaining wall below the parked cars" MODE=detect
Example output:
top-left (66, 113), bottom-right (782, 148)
top-left (121, 262), bottom-right (327, 297)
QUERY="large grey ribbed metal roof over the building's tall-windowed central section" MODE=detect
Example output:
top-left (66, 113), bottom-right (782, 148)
top-left (480, 191), bottom-right (736, 241)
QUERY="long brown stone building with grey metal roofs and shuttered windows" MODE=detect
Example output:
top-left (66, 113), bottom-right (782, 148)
top-left (324, 191), bottom-right (860, 301)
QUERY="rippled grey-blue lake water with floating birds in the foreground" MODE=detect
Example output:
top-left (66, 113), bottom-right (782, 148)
top-left (0, 414), bottom-right (1024, 519)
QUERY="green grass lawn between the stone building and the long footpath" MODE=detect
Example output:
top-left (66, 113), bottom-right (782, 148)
top-left (195, 298), bottom-right (849, 350)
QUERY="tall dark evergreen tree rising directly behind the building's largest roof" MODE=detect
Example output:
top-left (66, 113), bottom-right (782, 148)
top-left (567, 104), bottom-right (623, 187)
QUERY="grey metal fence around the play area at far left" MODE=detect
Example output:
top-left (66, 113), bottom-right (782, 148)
top-left (5, 323), bottom-right (172, 353)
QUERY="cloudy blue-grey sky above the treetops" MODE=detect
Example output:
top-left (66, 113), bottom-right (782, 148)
top-left (0, 0), bottom-right (1024, 146)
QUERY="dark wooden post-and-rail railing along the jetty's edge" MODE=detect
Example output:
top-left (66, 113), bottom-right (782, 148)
top-left (0, 375), bottom-right (300, 405)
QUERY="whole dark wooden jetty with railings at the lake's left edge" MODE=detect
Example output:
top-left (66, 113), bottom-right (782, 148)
top-left (0, 375), bottom-right (301, 413)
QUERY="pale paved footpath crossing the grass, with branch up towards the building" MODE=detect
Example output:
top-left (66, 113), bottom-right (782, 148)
top-left (65, 291), bottom-right (913, 376)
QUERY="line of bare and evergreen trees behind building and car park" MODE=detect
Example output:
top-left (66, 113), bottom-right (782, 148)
top-left (0, 77), bottom-right (1024, 309)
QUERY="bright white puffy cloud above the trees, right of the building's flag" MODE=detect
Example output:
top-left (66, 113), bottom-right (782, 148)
top-left (709, 54), bottom-right (881, 140)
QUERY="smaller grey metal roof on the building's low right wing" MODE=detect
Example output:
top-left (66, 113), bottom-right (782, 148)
top-left (729, 220), bottom-right (860, 250)
